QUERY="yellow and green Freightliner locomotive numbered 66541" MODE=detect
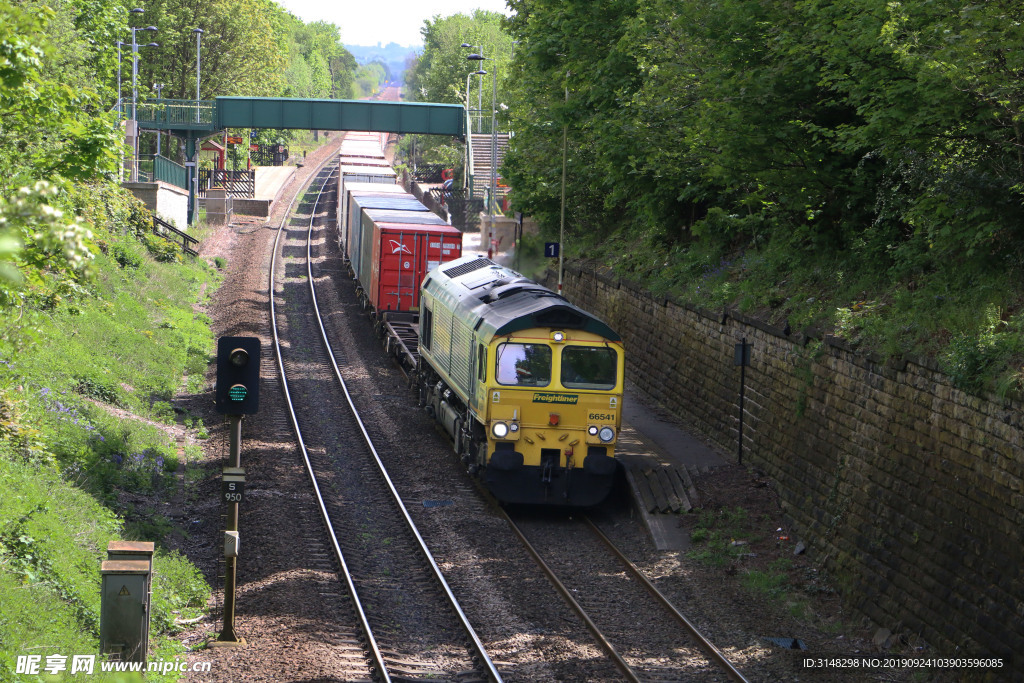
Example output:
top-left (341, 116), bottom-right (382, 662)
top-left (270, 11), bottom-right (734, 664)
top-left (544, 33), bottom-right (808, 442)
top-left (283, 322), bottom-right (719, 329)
top-left (418, 257), bottom-right (624, 506)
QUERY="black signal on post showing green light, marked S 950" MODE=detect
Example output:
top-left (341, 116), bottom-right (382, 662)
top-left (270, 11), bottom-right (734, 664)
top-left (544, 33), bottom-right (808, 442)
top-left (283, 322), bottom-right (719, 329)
top-left (208, 337), bottom-right (260, 647)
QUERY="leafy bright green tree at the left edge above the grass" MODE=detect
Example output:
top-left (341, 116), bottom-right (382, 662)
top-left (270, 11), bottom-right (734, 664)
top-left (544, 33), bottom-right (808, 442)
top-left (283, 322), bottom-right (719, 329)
top-left (0, 0), bottom-right (118, 301)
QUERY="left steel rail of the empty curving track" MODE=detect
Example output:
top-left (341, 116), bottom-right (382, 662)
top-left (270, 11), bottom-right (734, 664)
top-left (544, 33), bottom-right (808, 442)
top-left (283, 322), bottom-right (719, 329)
top-left (269, 155), bottom-right (391, 683)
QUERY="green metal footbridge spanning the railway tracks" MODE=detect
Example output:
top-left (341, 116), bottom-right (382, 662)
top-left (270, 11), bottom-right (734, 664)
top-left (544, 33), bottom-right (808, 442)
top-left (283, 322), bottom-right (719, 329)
top-left (137, 97), bottom-right (466, 223)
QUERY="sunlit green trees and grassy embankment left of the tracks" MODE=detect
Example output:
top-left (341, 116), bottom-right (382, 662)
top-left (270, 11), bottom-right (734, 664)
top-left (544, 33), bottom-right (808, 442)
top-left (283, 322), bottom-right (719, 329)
top-left (0, 5), bottom-right (215, 681)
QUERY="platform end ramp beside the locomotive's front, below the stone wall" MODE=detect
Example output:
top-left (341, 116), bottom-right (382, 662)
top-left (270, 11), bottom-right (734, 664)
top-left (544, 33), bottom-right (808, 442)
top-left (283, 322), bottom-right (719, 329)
top-left (615, 391), bottom-right (726, 550)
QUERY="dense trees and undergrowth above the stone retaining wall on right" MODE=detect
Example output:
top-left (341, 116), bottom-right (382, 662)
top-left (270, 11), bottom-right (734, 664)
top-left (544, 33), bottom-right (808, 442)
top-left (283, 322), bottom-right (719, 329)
top-left (502, 0), bottom-right (1024, 392)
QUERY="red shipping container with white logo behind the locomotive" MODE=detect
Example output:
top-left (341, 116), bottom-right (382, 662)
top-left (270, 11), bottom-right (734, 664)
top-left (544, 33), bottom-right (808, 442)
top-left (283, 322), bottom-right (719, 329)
top-left (367, 223), bottom-right (462, 311)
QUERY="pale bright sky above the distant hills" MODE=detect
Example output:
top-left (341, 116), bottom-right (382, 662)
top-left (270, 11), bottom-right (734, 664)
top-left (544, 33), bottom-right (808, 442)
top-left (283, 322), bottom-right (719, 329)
top-left (276, 0), bottom-right (511, 46)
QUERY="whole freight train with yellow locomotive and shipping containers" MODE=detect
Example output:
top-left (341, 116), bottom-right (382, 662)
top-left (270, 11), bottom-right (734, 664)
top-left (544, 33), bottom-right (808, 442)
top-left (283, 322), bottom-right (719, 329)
top-left (338, 133), bottom-right (624, 507)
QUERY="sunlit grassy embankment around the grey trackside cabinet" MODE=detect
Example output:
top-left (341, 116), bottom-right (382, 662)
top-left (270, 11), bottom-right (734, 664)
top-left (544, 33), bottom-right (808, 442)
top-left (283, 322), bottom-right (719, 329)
top-left (0, 192), bottom-right (217, 681)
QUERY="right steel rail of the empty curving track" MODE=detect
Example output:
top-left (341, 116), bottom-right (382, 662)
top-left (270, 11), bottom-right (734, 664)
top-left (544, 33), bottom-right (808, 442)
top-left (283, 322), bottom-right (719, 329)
top-left (306, 161), bottom-right (502, 683)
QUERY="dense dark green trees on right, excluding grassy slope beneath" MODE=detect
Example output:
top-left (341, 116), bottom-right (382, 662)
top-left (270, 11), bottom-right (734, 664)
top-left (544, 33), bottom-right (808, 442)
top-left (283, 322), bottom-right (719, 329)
top-left (505, 0), bottom-right (1024, 267)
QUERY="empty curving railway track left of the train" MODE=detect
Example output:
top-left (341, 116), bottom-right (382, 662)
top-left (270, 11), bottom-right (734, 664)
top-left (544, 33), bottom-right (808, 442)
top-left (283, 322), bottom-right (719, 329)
top-left (269, 152), bottom-right (501, 682)
